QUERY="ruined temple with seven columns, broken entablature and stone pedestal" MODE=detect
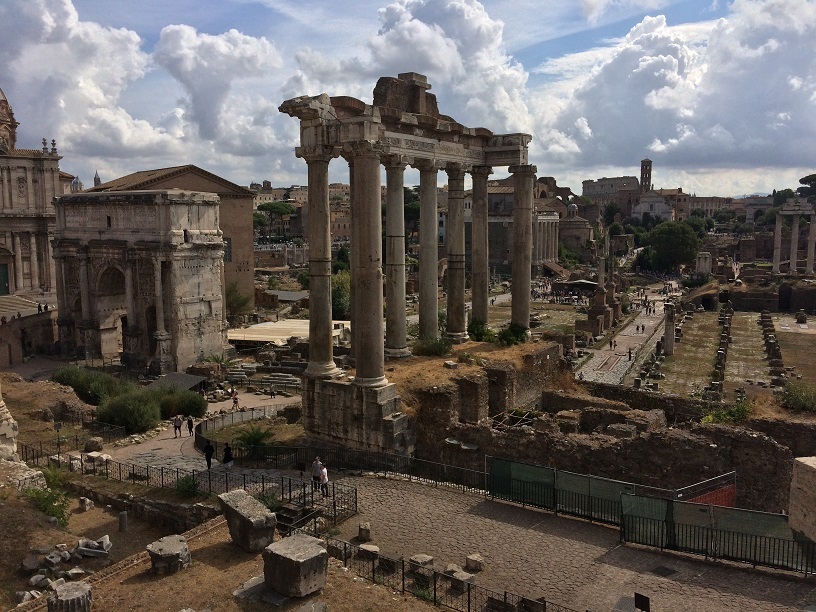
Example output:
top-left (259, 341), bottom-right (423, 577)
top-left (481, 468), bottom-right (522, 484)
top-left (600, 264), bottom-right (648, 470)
top-left (279, 73), bottom-right (536, 452)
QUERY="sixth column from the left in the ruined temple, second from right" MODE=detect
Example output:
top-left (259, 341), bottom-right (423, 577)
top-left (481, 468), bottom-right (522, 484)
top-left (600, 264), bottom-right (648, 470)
top-left (470, 166), bottom-right (493, 324)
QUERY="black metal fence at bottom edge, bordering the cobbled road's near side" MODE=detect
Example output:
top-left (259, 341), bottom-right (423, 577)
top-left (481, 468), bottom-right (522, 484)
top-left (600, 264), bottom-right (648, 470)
top-left (316, 537), bottom-right (577, 612)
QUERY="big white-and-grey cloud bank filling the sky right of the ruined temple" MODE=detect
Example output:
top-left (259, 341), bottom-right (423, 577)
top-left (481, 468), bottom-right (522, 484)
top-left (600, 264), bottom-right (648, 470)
top-left (539, 0), bottom-right (816, 182)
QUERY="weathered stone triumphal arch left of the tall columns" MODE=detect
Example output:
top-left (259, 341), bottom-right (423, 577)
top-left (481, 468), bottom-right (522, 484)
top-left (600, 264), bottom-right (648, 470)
top-left (54, 189), bottom-right (226, 374)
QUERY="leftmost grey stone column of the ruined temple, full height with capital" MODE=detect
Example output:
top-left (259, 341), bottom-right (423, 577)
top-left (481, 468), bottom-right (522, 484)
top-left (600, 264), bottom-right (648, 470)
top-left (297, 146), bottom-right (340, 378)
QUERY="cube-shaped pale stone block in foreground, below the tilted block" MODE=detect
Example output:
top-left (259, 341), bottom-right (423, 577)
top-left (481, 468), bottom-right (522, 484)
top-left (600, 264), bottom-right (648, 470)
top-left (263, 534), bottom-right (329, 597)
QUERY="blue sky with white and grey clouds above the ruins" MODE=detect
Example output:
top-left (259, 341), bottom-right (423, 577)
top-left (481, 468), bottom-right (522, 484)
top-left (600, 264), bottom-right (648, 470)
top-left (0, 0), bottom-right (816, 196)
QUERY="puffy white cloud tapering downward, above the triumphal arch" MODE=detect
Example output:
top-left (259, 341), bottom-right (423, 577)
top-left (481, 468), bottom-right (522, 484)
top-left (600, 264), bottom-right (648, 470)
top-left (154, 25), bottom-right (282, 140)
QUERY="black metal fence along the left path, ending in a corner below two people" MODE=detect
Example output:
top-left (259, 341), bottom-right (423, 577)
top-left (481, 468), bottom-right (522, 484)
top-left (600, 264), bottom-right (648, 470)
top-left (18, 444), bottom-right (357, 533)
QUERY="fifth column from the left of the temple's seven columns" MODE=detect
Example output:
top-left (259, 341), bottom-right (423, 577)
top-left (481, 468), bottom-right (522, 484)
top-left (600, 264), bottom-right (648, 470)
top-left (445, 164), bottom-right (467, 343)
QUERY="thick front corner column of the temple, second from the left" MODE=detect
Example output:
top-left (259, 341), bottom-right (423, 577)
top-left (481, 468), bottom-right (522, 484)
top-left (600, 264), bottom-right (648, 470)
top-left (345, 141), bottom-right (388, 387)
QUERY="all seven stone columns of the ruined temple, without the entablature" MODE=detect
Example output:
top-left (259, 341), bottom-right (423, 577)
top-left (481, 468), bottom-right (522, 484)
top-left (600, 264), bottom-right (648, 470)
top-left (297, 141), bottom-right (536, 387)
